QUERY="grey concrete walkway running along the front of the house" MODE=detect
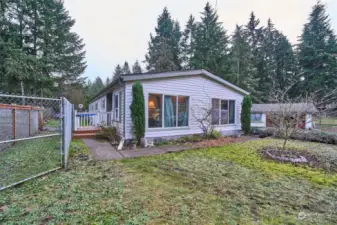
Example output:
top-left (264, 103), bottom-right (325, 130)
top-left (82, 139), bottom-right (193, 161)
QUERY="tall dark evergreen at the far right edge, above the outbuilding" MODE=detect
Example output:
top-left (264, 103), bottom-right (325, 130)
top-left (297, 1), bottom-right (337, 103)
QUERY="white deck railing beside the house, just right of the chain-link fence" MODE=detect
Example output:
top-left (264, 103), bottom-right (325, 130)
top-left (75, 112), bottom-right (112, 130)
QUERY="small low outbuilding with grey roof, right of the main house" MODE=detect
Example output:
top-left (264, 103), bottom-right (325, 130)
top-left (251, 103), bottom-right (318, 129)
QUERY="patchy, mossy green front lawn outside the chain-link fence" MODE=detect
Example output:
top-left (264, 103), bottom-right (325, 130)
top-left (0, 139), bottom-right (337, 224)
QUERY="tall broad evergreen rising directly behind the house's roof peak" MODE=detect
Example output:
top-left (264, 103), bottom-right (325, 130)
top-left (191, 3), bottom-right (228, 77)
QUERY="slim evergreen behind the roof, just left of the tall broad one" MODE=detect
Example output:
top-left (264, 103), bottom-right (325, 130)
top-left (181, 15), bottom-right (197, 69)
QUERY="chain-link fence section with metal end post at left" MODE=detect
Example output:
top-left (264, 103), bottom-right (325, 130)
top-left (0, 94), bottom-right (73, 191)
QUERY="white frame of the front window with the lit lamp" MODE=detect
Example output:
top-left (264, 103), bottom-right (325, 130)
top-left (146, 93), bottom-right (191, 130)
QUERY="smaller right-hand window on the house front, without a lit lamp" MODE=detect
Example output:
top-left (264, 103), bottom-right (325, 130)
top-left (212, 99), bottom-right (235, 125)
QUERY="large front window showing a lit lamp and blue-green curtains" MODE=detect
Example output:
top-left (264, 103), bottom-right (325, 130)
top-left (148, 94), bottom-right (189, 128)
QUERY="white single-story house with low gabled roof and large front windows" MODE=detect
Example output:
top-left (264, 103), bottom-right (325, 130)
top-left (89, 70), bottom-right (249, 140)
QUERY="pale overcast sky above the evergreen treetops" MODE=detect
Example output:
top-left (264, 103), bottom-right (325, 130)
top-left (64, 0), bottom-right (337, 80)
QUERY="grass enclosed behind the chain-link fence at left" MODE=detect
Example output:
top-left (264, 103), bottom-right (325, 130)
top-left (0, 136), bottom-right (61, 187)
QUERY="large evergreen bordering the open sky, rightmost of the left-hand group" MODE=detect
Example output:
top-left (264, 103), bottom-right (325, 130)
top-left (42, 0), bottom-right (86, 93)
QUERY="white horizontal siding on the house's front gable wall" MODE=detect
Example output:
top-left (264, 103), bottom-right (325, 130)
top-left (125, 75), bottom-right (243, 139)
